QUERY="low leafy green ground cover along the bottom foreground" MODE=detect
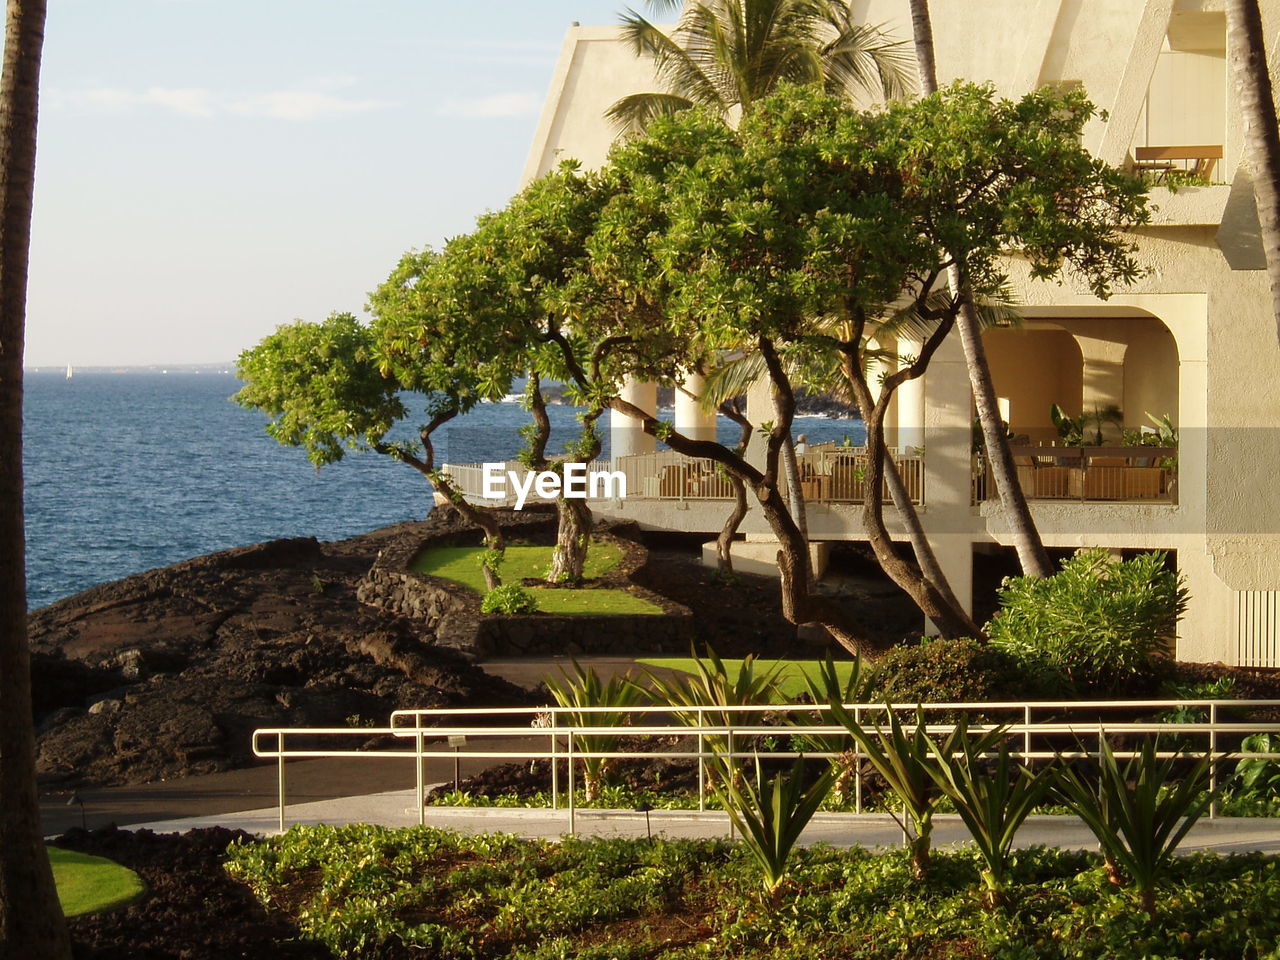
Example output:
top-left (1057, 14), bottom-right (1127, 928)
top-left (227, 824), bottom-right (1280, 960)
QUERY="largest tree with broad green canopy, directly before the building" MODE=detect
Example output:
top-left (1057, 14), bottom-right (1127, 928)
top-left (591, 86), bottom-right (1146, 648)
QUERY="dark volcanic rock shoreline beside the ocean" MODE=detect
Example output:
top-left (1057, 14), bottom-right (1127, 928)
top-left (29, 511), bottom-right (527, 786)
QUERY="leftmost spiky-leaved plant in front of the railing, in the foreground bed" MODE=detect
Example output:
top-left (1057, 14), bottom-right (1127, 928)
top-left (712, 756), bottom-right (836, 902)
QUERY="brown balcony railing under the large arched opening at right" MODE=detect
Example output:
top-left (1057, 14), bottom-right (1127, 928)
top-left (974, 445), bottom-right (1178, 503)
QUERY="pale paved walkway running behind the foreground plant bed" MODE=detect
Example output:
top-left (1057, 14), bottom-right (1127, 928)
top-left (122, 790), bottom-right (1280, 854)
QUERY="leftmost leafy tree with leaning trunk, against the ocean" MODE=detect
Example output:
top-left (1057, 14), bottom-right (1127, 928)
top-left (233, 314), bottom-right (509, 589)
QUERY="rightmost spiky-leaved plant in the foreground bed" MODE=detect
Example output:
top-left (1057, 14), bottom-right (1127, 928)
top-left (1056, 737), bottom-right (1213, 919)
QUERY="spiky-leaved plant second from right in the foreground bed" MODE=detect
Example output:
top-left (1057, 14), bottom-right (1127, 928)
top-left (929, 719), bottom-right (1059, 909)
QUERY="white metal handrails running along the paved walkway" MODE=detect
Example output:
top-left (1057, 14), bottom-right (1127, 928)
top-left (253, 699), bottom-right (1280, 833)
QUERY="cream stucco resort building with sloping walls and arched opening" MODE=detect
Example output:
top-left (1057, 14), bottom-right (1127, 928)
top-left (448, 0), bottom-right (1280, 666)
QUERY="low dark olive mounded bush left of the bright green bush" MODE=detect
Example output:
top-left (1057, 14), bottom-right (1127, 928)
top-left (869, 637), bottom-right (1062, 703)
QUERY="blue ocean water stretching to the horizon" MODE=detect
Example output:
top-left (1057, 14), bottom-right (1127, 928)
top-left (24, 370), bottom-right (861, 609)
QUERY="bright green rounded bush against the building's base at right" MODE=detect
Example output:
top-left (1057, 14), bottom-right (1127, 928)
top-left (987, 549), bottom-right (1188, 695)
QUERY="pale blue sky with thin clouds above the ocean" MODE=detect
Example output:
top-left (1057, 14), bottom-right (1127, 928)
top-left (26, 0), bottom-right (640, 367)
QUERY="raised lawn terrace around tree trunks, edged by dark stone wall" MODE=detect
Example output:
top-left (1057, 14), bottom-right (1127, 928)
top-left (410, 543), bottom-right (662, 614)
